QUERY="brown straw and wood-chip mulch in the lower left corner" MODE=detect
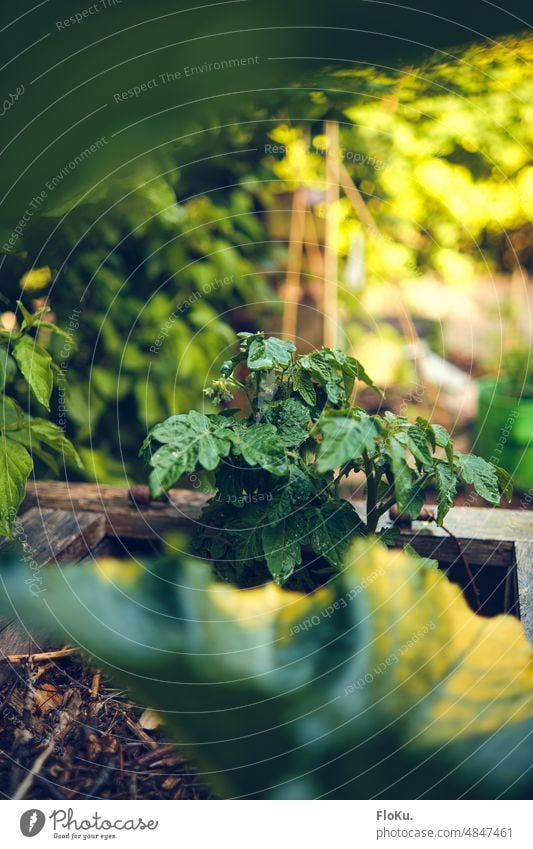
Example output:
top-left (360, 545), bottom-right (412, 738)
top-left (0, 654), bottom-right (211, 800)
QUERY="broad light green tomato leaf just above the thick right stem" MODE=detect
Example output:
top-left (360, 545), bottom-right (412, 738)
top-left (316, 416), bottom-right (378, 474)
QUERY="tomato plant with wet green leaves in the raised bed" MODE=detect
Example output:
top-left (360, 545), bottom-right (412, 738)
top-left (141, 333), bottom-right (510, 587)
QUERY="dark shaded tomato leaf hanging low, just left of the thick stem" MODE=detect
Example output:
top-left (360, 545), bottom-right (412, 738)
top-left (311, 499), bottom-right (366, 569)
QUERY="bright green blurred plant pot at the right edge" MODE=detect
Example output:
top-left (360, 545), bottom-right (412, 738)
top-left (472, 378), bottom-right (533, 492)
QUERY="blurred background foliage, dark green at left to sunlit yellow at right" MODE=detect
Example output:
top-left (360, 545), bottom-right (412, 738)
top-left (0, 39), bottom-right (533, 482)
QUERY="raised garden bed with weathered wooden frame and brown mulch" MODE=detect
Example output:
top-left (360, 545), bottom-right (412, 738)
top-left (0, 483), bottom-right (533, 799)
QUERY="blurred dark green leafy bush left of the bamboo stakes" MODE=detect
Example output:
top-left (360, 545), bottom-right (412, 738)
top-left (2, 147), bottom-right (272, 482)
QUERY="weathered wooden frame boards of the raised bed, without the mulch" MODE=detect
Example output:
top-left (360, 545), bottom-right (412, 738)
top-left (0, 482), bottom-right (533, 659)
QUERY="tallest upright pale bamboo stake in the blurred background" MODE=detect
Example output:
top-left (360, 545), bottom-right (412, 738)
top-left (323, 121), bottom-right (340, 348)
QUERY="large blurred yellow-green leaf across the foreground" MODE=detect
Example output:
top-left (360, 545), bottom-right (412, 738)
top-left (1, 541), bottom-right (533, 799)
